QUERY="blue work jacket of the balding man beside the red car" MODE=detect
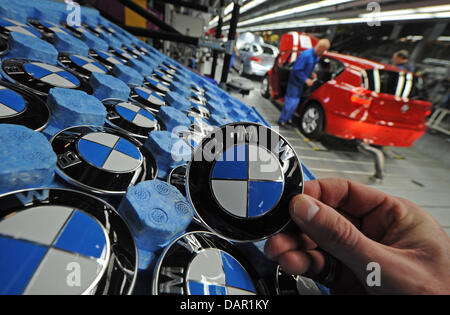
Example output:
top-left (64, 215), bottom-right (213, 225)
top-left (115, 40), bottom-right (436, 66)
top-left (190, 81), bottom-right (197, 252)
top-left (286, 48), bottom-right (319, 98)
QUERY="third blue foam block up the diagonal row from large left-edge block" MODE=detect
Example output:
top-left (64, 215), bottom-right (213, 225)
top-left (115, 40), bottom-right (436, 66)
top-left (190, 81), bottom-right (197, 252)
top-left (89, 73), bottom-right (131, 100)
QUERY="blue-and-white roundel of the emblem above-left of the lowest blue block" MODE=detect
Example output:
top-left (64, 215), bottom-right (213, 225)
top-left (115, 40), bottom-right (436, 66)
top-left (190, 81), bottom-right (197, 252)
top-left (78, 132), bottom-right (143, 173)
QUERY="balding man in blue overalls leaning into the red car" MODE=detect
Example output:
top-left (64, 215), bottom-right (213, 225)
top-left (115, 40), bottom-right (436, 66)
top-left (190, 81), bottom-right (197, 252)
top-left (278, 39), bottom-right (331, 126)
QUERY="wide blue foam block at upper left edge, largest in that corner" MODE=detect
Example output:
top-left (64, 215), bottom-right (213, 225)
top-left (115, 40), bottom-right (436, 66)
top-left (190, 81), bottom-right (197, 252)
top-left (3, 32), bottom-right (58, 65)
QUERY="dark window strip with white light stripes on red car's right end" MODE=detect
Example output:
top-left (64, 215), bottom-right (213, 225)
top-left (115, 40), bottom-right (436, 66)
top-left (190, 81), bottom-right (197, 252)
top-left (362, 69), bottom-right (420, 98)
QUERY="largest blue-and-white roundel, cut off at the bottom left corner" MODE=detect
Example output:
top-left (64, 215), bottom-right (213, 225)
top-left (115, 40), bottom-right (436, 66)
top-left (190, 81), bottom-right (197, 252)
top-left (0, 206), bottom-right (110, 295)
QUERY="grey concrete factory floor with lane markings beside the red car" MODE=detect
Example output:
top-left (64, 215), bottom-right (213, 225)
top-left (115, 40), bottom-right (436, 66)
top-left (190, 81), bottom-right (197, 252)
top-left (224, 72), bottom-right (450, 235)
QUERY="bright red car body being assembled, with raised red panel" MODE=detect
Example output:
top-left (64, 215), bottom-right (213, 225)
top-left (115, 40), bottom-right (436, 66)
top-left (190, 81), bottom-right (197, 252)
top-left (265, 33), bottom-right (431, 147)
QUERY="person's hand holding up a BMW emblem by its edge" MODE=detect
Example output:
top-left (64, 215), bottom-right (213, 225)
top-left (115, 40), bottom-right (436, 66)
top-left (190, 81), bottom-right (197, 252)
top-left (265, 179), bottom-right (450, 294)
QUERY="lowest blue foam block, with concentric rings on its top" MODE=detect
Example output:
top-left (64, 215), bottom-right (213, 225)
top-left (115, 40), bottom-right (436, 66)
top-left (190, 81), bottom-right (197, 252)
top-left (118, 180), bottom-right (194, 252)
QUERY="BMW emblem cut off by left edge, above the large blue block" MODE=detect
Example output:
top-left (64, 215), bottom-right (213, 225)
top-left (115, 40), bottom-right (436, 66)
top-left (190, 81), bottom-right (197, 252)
top-left (0, 81), bottom-right (50, 131)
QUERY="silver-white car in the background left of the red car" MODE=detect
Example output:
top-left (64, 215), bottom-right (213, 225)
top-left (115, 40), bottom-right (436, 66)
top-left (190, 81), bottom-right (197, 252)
top-left (233, 43), bottom-right (279, 77)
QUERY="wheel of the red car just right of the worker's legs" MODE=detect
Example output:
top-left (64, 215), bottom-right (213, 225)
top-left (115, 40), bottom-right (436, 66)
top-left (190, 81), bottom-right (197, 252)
top-left (300, 103), bottom-right (325, 140)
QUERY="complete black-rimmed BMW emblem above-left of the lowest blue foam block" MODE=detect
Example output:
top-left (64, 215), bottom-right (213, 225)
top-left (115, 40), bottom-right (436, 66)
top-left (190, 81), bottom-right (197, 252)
top-left (50, 126), bottom-right (157, 195)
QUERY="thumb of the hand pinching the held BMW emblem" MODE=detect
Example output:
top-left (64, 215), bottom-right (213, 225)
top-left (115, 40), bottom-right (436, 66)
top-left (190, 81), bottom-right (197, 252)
top-left (290, 195), bottom-right (377, 271)
